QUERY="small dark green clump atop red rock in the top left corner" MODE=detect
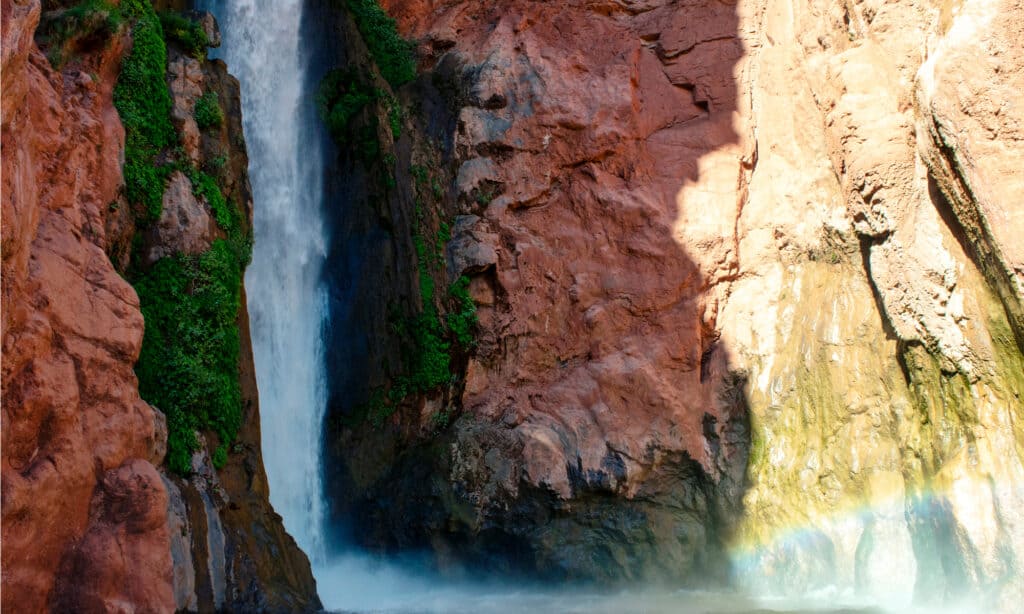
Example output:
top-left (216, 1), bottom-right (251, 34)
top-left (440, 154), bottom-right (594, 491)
top-left (36, 0), bottom-right (124, 69)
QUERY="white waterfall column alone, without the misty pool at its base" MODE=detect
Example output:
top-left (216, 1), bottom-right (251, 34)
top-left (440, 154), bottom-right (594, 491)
top-left (198, 0), bottom-right (327, 564)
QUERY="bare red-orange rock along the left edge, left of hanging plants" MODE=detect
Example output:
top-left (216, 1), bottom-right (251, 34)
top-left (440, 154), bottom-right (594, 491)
top-left (3, 2), bottom-right (174, 612)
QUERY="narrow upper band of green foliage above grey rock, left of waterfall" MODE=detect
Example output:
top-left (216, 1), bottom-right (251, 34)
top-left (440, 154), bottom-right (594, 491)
top-left (114, 0), bottom-right (177, 225)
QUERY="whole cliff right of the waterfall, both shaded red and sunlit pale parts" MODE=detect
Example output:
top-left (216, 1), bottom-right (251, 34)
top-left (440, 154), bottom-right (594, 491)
top-left (325, 0), bottom-right (1024, 610)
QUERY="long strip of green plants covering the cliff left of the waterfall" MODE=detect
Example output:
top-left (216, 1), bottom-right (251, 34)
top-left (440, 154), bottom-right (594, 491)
top-left (114, 0), bottom-right (252, 474)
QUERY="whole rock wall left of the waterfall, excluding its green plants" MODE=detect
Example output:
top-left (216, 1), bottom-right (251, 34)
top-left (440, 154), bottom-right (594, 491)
top-left (2, 0), bottom-right (318, 612)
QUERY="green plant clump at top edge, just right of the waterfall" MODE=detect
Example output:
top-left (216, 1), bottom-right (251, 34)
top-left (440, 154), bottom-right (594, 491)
top-left (345, 0), bottom-right (416, 87)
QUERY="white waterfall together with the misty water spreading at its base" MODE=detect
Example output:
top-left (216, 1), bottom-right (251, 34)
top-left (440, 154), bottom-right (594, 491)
top-left (198, 0), bottom-right (991, 613)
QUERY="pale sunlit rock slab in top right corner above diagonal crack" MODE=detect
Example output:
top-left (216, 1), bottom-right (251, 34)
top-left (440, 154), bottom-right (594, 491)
top-left (915, 0), bottom-right (1024, 336)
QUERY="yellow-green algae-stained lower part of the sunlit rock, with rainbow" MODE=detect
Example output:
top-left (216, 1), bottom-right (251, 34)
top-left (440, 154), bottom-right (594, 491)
top-left (731, 236), bottom-right (1024, 605)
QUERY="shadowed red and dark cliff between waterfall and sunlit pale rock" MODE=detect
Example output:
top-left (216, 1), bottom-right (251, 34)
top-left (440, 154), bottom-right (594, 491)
top-left (326, 0), bottom-right (756, 585)
